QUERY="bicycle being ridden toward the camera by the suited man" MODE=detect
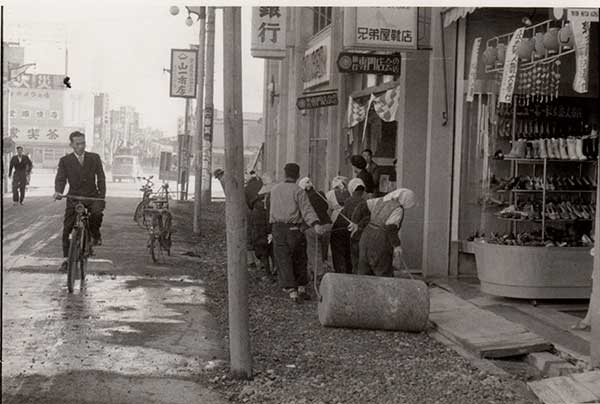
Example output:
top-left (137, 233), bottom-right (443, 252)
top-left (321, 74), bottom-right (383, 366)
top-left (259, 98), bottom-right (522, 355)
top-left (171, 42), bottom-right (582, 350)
top-left (58, 195), bottom-right (104, 293)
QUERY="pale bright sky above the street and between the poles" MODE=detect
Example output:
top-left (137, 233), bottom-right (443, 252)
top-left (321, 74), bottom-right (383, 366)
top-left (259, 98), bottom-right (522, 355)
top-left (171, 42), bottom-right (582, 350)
top-left (4, 0), bottom-right (264, 136)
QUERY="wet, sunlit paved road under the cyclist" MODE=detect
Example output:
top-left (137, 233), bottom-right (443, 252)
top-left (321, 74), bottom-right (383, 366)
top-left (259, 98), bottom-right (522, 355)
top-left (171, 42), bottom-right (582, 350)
top-left (2, 183), bottom-right (225, 404)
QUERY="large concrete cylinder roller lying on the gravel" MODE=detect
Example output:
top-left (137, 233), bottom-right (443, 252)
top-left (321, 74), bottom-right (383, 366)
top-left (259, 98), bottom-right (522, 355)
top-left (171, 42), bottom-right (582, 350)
top-left (318, 272), bottom-right (429, 332)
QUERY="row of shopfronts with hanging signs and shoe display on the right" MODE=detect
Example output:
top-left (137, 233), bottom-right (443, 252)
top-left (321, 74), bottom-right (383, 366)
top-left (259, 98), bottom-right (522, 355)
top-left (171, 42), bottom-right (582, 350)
top-left (260, 7), bottom-right (600, 366)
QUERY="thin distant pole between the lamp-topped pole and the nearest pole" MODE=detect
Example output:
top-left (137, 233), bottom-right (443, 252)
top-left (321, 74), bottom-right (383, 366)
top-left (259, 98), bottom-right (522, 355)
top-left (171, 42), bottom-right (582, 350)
top-left (201, 7), bottom-right (215, 206)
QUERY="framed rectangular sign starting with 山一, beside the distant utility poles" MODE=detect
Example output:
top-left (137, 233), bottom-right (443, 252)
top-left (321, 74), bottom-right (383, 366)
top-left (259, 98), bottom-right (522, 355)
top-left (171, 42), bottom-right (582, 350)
top-left (170, 49), bottom-right (198, 98)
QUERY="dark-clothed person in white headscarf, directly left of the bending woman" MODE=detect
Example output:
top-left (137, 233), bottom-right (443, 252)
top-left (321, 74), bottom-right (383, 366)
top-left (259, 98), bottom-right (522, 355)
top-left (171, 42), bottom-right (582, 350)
top-left (342, 178), bottom-right (371, 274)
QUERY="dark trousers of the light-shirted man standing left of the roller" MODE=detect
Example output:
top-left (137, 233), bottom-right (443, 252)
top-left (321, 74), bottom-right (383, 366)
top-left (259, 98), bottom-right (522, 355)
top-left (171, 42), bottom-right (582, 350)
top-left (272, 223), bottom-right (308, 288)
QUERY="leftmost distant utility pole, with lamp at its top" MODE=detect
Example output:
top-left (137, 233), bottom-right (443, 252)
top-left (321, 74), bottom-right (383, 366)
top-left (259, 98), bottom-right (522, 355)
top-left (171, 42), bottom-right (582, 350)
top-left (195, 7), bottom-right (206, 234)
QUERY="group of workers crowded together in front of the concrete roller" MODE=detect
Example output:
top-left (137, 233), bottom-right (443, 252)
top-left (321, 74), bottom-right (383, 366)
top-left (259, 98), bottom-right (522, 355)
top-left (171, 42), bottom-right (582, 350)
top-left (245, 149), bottom-right (415, 301)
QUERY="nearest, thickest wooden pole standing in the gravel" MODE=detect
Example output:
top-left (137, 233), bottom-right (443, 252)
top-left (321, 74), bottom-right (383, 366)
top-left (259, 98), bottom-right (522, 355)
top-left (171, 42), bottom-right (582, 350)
top-left (223, 7), bottom-right (252, 379)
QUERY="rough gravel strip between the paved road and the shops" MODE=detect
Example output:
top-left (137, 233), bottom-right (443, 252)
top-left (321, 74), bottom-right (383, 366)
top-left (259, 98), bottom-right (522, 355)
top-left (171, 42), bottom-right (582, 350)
top-left (174, 203), bottom-right (538, 404)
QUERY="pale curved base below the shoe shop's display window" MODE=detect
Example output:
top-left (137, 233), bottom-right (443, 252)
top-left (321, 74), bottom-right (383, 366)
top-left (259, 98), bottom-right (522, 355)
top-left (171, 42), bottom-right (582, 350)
top-left (472, 242), bottom-right (593, 299)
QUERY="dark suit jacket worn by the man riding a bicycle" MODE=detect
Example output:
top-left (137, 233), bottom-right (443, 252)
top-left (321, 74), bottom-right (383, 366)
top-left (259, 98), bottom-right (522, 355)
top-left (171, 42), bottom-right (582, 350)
top-left (54, 152), bottom-right (106, 198)
